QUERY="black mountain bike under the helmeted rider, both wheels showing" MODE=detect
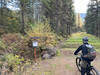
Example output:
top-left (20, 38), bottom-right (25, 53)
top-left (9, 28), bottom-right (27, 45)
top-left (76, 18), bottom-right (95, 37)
top-left (76, 53), bottom-right (100, 75)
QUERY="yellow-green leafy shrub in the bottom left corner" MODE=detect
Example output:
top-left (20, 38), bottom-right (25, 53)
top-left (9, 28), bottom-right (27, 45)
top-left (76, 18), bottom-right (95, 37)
top-left (0, 54), bottom-right (24, 71)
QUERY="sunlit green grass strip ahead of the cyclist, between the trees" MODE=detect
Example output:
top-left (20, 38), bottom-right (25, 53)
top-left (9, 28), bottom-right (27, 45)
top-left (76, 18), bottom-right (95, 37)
top-left (62, 32), bottom-right (100, 51)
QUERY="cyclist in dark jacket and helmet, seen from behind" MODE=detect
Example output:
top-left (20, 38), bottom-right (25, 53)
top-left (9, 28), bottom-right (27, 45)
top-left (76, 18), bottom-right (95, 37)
top-left (74, 37), bottom-right (93, 75)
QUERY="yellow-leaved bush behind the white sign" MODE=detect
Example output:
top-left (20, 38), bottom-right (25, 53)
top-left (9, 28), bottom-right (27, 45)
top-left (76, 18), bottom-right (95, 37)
top-left (26, 22), bottom-right (57, 46)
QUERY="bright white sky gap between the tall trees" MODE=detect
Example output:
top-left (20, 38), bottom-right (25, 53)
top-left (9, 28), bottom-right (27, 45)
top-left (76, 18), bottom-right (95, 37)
top-left (73, 0), bottom-right (90, 13)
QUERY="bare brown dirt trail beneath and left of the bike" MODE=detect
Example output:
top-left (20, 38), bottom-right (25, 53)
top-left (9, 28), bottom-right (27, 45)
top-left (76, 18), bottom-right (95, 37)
top-left (34, 50), bottom-right (100, 75)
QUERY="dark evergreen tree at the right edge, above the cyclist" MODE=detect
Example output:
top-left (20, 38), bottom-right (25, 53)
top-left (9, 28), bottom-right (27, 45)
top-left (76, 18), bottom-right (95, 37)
top-left (85, 0), bottom-right (100, 37)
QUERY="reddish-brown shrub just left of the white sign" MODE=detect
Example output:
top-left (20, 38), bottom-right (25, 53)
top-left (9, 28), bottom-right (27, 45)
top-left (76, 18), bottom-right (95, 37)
top-left (2, 33), bottom-right (33, 59)
